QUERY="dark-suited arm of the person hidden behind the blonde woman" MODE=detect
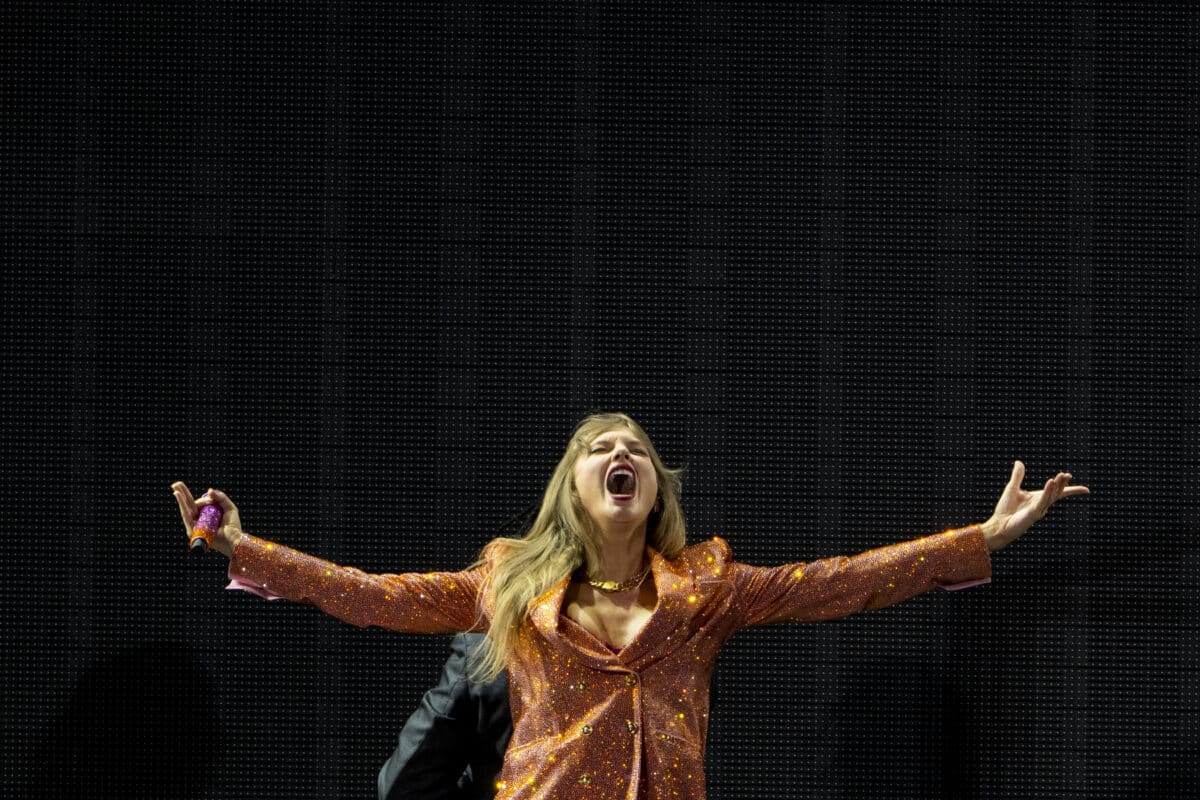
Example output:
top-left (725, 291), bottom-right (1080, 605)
top-left (378, 633), bottom-right (512, 800)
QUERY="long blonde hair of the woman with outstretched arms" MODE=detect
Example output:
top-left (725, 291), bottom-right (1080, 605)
top-left (470, 414), bottom-right (686, 680)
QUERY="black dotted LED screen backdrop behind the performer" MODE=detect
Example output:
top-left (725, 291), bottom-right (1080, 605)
top-left (0, 1), bottom-right (1200, 799)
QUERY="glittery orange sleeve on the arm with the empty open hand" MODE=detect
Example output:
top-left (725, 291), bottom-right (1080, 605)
top-left (731, 525), bottom-right (991, 626)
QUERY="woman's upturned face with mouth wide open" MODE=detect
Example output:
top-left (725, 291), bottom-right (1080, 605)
top-left (575, 428), bottom-right (659, 528)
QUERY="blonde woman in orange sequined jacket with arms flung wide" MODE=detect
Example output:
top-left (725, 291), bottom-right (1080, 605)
top-left (173, 414), bottom-right (1087, 800)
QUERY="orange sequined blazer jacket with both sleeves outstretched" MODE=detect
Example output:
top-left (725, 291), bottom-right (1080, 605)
top-left (229, 525), bottom-right (991, 800)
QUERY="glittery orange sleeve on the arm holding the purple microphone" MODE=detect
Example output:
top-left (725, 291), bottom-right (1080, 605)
top-left (229, 534), bottom-right (487, 633)
